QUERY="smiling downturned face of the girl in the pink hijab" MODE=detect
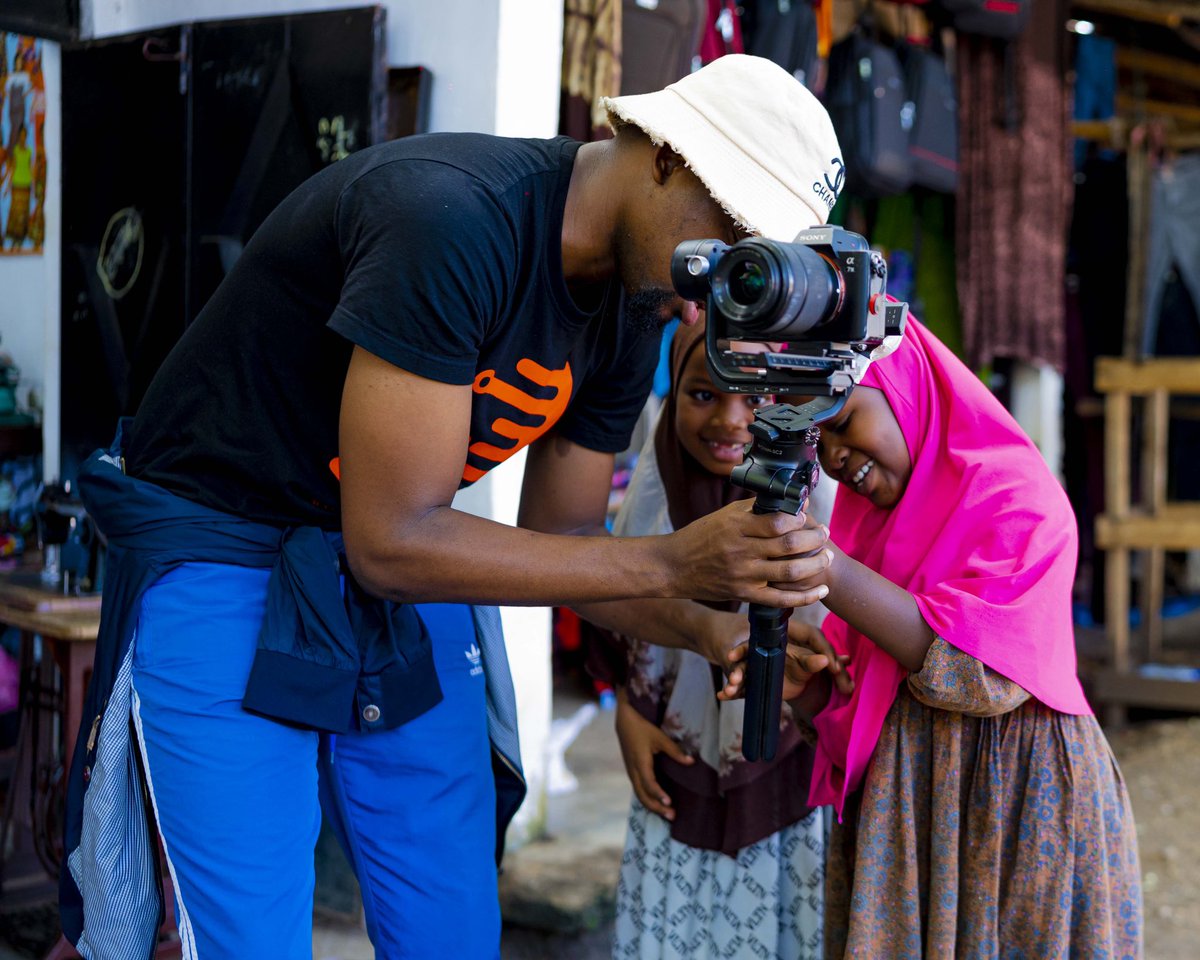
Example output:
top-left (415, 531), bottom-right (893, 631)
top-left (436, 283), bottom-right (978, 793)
top-left (817, 386), bottom-right (912, 510)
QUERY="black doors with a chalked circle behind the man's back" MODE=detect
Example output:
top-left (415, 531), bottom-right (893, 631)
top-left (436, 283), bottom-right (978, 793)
top-left (61, 7), bottom-right (388, 479)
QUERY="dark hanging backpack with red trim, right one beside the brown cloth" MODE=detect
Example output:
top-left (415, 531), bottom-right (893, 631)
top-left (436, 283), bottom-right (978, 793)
top-left (900, 43), bottom-right (959, 193)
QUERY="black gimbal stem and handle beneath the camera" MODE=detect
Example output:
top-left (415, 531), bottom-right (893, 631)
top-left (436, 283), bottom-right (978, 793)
top-left (731, 394), bottom-right (847, 761)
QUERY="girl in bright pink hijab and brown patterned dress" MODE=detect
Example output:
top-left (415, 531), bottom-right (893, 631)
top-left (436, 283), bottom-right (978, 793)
top-left (777, 320), bottom-right (1142, 960)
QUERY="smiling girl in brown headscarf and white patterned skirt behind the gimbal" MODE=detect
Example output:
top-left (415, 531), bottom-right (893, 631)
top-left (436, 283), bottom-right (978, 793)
top-left (600, 323), bottom-right (850, 960)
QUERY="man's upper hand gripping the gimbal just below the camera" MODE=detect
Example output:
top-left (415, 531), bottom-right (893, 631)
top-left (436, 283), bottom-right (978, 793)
top-left (662, 499), bottom-right (832, 607)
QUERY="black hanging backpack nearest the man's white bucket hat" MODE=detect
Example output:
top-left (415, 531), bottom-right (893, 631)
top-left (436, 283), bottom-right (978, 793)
top-left (826, 30), bottom-right (912, 197)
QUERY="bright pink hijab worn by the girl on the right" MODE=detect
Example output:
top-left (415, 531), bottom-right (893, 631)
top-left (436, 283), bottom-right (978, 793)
top-left (809, 319), bottom-right (1092, 816)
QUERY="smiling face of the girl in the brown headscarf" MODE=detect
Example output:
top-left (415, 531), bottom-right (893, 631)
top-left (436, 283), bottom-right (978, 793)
top-left (676, 344), bottom-right (774, 476)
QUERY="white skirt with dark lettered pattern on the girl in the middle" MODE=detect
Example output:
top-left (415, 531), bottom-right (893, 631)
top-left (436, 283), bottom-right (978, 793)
top-left (612, 798), bottom-right (824, 960)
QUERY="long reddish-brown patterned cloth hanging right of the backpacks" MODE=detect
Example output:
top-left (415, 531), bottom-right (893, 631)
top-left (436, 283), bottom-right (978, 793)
top-left (956, 0), bottom-right (1073, 370)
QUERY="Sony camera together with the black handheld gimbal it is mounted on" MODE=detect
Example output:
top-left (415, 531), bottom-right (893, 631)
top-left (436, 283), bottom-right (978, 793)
top-left (671, 220), bottom-right (908, 761)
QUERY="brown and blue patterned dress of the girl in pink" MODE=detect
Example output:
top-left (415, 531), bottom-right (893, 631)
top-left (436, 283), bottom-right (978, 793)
top-left (826, 640), bottom-right (1142, 960)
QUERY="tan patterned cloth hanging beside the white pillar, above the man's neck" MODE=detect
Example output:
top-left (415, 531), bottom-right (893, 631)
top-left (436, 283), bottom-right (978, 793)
top-left (558, 0), bottom-right (622, 140)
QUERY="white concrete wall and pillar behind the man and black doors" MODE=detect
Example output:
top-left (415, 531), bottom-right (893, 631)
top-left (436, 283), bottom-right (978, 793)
top-left (0, 0), bottom-right (562, 842)
